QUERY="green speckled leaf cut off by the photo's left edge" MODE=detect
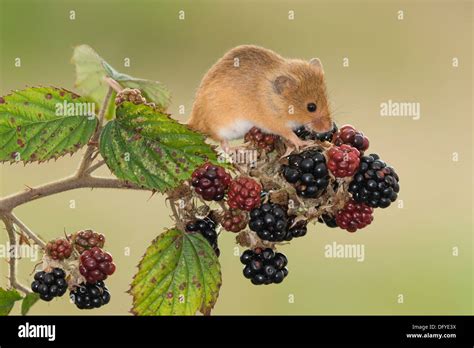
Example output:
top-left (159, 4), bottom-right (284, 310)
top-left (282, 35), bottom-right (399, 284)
top-left (0, 87), bottom-right (97, 163)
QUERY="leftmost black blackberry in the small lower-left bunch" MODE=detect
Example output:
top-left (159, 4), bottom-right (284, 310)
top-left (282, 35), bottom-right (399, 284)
top-left (31, 268), bottom-right (67, 302)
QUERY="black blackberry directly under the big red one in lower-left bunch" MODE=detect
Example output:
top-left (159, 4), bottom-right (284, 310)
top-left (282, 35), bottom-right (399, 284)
top-left (69, 281), bottom-right (110, 309)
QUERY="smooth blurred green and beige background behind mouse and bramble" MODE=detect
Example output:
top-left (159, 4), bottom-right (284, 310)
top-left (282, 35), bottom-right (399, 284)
top-left (0, 0), bottom-right (473, 315)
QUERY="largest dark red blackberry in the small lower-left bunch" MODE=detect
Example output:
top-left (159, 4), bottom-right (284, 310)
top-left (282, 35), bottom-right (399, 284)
top-left (79, 247), bottom-right (115, 284)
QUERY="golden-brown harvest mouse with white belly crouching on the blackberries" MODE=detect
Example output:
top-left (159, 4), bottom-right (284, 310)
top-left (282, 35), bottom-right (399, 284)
top-left (188, 45), bottom-right (332, 149)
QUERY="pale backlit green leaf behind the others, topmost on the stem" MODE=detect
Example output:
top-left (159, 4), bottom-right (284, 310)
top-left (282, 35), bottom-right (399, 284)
top-left (72, 45), bottom-right (171, 119)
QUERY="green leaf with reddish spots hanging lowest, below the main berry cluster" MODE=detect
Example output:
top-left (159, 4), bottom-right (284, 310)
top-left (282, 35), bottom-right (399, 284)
top-left (130, 229), bottom-right (222, 315)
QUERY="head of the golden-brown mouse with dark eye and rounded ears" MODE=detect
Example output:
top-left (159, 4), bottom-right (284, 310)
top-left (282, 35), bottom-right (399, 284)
top-left (272, 58), bottom-right (332, 132)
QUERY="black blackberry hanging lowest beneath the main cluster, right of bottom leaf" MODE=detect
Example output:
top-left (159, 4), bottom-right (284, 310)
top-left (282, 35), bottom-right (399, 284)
top-left (240, 248), bottom-right (288, 285)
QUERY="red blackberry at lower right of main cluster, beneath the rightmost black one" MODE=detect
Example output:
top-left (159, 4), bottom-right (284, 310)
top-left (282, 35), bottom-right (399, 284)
top-left (336, 200), bottom-right (374, 232)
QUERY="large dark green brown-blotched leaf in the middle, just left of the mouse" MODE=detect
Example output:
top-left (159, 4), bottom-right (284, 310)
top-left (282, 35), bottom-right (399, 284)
top-left (100, 102), bottom-right (217, 192)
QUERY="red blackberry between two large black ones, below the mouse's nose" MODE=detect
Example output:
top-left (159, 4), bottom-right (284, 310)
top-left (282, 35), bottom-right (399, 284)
top-left (327, 144), bottom-right (360, 178)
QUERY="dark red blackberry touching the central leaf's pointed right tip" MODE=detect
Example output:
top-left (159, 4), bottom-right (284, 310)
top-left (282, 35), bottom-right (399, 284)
top-left (191, 163), bottom-right (232, 201)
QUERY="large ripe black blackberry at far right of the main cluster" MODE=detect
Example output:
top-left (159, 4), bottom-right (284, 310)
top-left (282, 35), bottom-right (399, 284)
top-left (349, 154), bottom-right (400, 208)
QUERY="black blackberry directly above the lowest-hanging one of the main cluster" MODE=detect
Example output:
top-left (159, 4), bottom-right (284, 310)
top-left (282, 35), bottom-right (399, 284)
top-left (249, 203), bottom-right (289, 242)
